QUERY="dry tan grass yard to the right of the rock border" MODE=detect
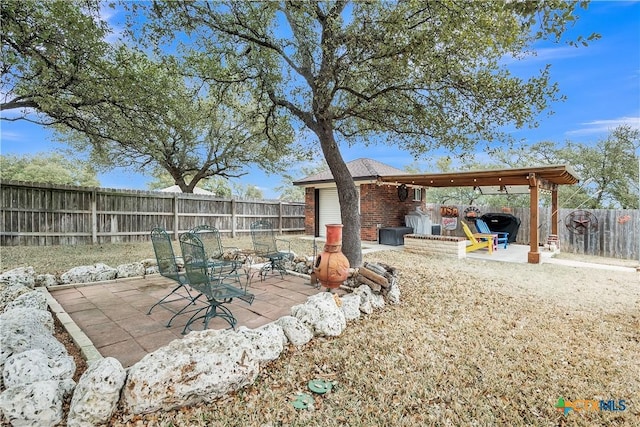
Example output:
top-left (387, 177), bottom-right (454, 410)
top-left (111, 252), bottom-right (640, 427)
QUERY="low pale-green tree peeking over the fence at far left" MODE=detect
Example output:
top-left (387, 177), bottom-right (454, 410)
top-left (0, 153), bottom-right (100, 187)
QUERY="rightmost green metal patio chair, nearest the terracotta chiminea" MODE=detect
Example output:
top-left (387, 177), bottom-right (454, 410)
top-left (251, 220), bottom-right (291, 280)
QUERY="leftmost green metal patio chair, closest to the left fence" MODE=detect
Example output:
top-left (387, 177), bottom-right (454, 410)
top-left (147, 227), bottom-right (202, 327)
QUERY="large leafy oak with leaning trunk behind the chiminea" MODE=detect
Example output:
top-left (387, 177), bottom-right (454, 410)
top-left (139, 0), bottom-right (596, 265)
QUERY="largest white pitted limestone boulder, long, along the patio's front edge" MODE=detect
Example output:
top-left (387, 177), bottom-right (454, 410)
top-left (123, 330), bottom-right (259, 414)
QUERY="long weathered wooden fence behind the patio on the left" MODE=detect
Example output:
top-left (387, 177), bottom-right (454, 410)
top-left (0, 181), bottom-right (304, 246)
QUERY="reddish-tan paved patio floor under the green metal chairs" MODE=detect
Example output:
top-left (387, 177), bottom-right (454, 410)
top-left (49, 274), bottom-right (324, 368)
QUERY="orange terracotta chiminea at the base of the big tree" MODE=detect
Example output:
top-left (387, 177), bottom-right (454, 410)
top-left (313, 224), bottom-right (349, 289)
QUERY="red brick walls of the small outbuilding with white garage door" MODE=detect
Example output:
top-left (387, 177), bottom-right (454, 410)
top-left (304, 184), bottom-right (426, 241)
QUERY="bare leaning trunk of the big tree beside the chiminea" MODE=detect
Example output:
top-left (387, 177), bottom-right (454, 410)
top-left (316, 122), bottom-right (362, 267)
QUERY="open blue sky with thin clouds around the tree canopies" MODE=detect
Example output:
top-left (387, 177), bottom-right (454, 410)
top-left (0, 1), bottom-right (640, 198)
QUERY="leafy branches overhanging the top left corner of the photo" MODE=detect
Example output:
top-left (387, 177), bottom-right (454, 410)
top-left (0, 0), bottom-right (110, 120)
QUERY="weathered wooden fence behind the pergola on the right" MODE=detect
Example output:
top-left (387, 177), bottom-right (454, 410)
top-left (427, 204), bottom-right (640, 260)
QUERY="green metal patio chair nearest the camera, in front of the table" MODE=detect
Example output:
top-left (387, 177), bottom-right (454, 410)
top-left (180, 232), bottom-right (255, 334)
